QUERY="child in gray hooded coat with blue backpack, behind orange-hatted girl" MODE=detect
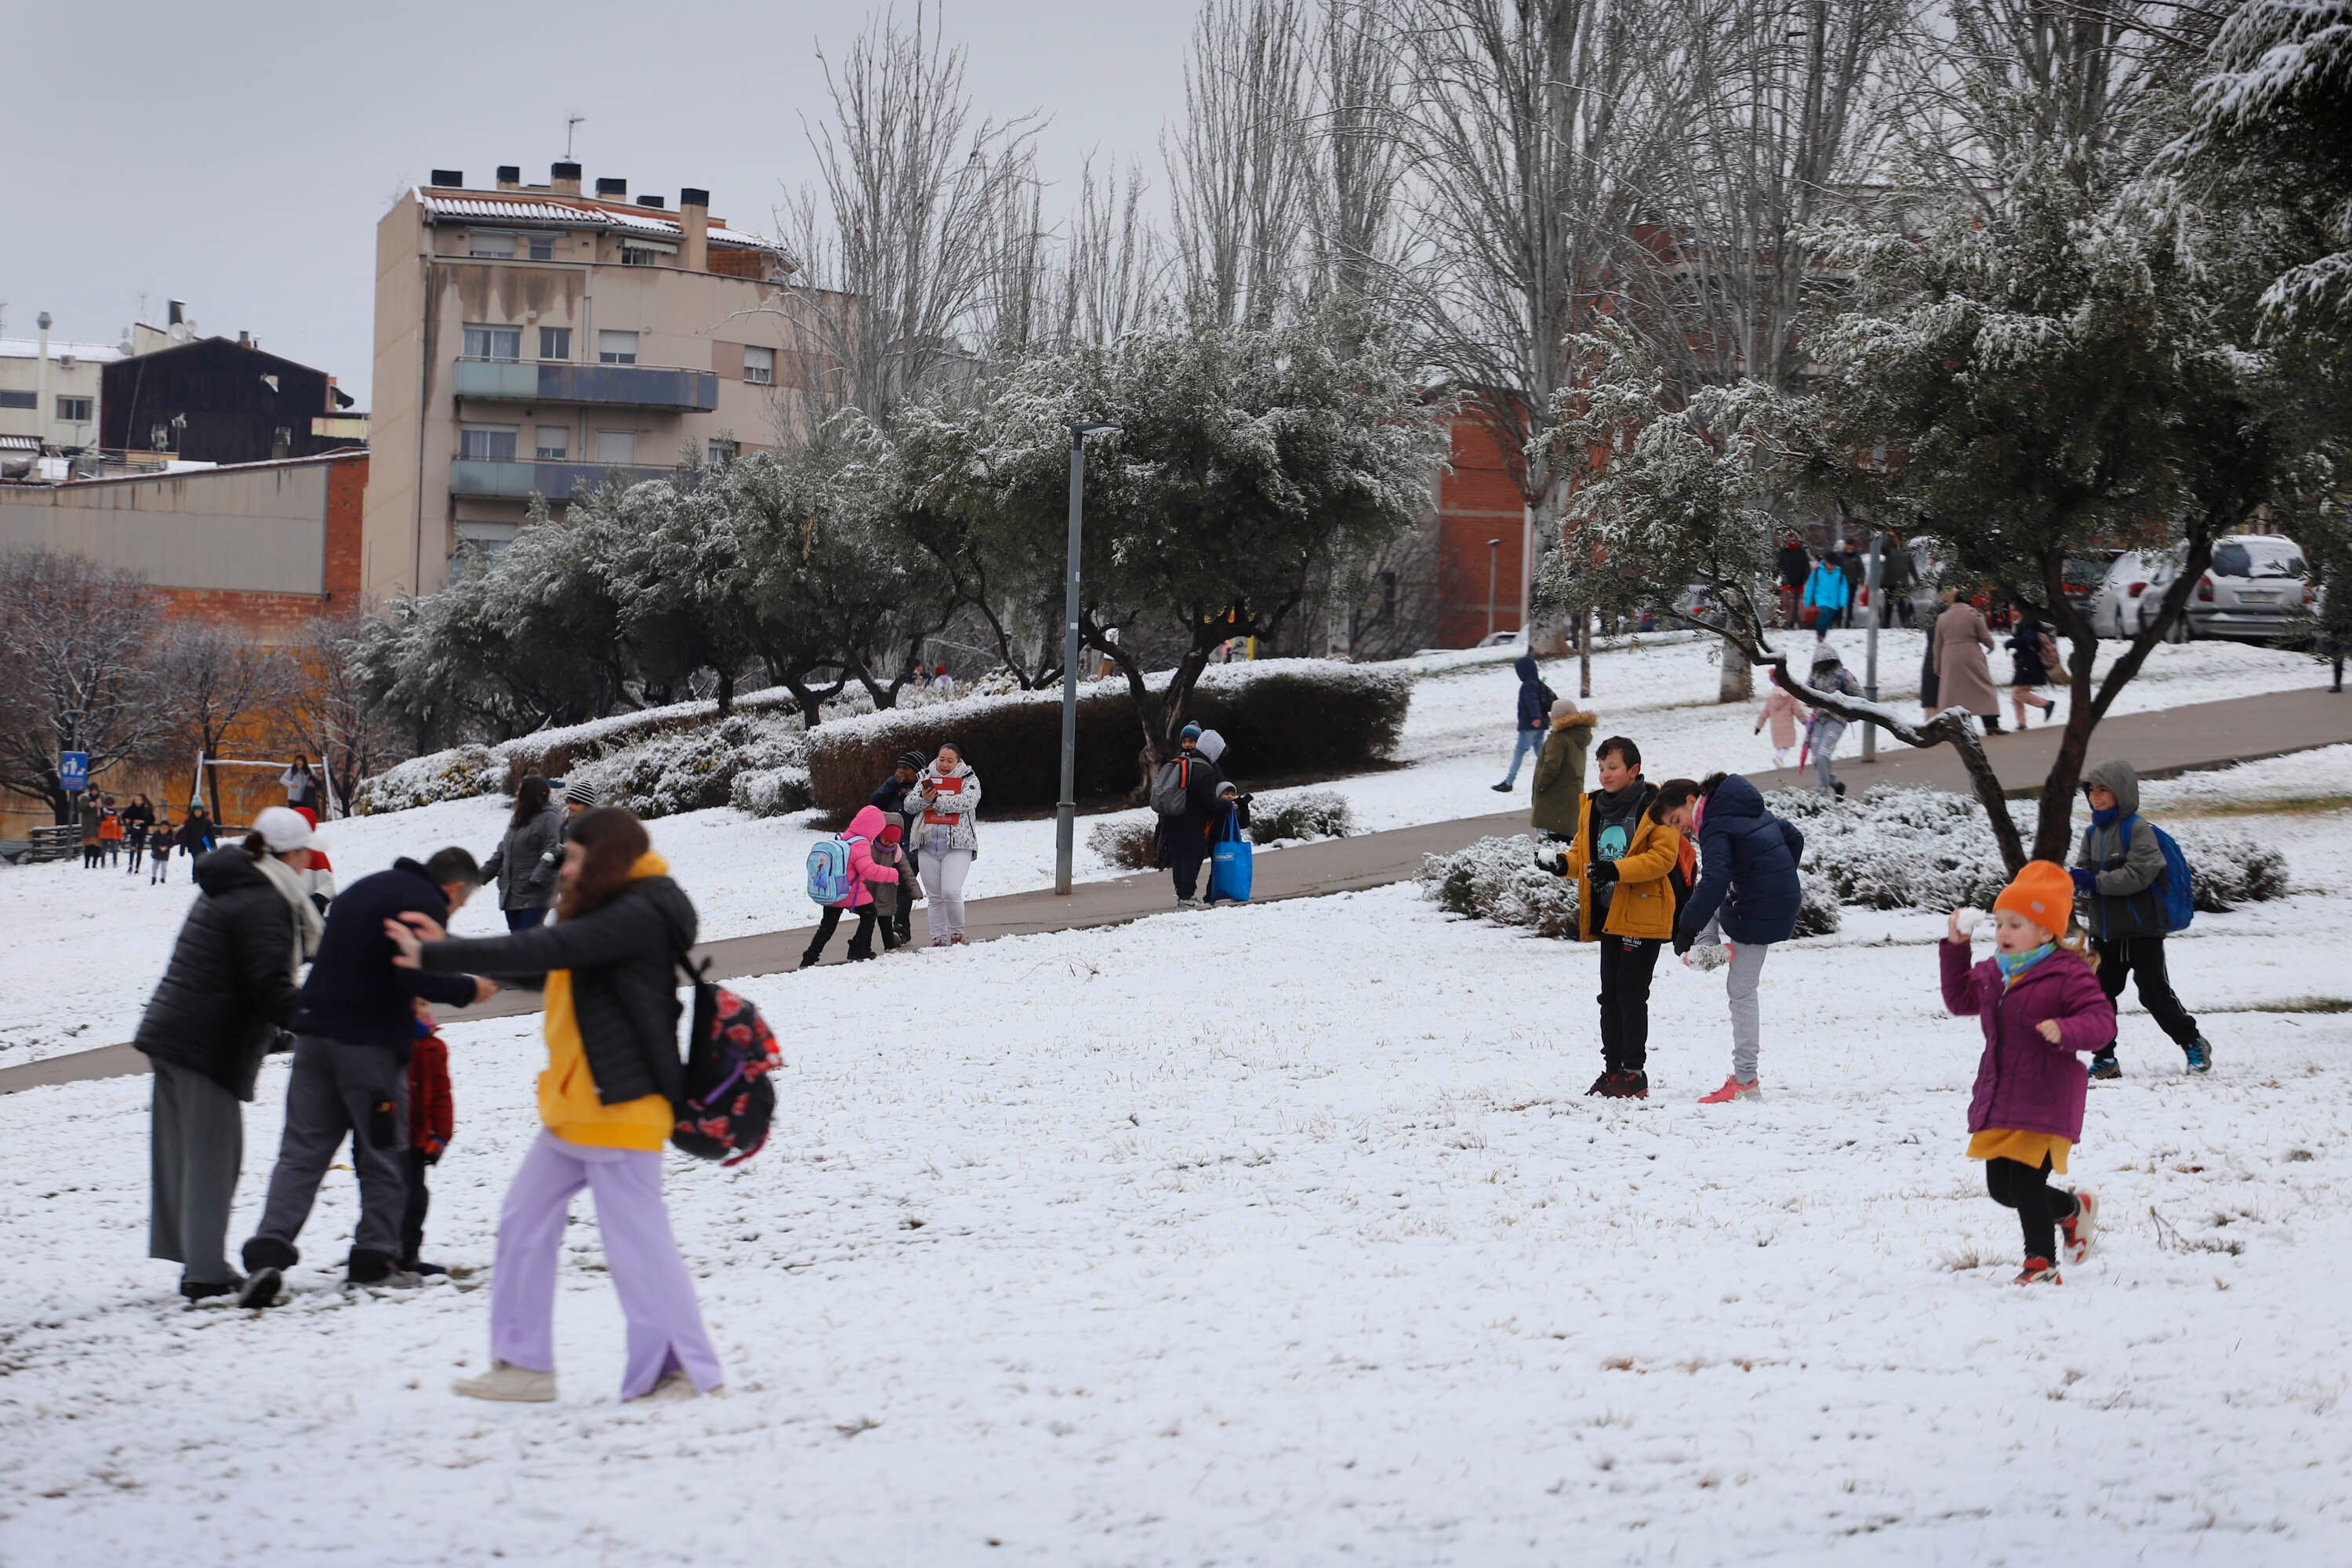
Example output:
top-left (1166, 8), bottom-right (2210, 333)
top-left (2072, 762), bottom-right (2213, 1079)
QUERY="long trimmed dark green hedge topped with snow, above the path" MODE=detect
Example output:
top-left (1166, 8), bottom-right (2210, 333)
top-left (809, 659), bottom-right (1414, 815)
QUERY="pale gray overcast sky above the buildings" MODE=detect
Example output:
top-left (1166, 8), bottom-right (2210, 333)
top-left (0, 0), bottom-right (1192, 407)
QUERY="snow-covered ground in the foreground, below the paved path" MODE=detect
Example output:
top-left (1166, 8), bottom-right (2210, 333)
top-left (0, 804), bottom-right (2352, 1566)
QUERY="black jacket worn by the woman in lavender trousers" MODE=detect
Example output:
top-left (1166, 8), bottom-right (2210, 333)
top-left (423, 877), bottom-right (696, 1105)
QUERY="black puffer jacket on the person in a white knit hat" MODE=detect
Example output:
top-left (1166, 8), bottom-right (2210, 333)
top-left (132, 844), bottom-right (299, 1100)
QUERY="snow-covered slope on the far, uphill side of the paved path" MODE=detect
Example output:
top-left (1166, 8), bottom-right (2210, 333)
top-left (0, 633), bottom-right (2324, 1067)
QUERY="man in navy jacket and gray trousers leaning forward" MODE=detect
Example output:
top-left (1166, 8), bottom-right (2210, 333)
top-left (238, 848), bottom-right (499, 1307)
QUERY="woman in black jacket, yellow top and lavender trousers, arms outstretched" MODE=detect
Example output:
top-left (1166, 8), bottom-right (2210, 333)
top-left (383, 806), bottom-right (724, 1401)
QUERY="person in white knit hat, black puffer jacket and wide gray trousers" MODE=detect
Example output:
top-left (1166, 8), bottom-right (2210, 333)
top-left (132, 808), bottom-right (320, 1302)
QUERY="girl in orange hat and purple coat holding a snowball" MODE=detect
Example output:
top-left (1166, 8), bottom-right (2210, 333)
top-left (1938, 860), bottom-right (2114, 1286)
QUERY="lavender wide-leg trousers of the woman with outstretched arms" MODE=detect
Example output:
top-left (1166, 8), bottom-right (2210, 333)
top-left (489, 1128), bottom-right (727, 1399)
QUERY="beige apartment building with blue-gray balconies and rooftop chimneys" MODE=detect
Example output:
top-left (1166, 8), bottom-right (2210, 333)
top-left (362, 162), bottom-right (797, 600)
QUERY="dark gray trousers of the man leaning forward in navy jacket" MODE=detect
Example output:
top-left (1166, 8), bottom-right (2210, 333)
top-left (254, 1034), bottom-right (409, 1260)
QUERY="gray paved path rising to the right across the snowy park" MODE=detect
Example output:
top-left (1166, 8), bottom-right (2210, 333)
top-left (13, 668), bottom-right (2352, 1093)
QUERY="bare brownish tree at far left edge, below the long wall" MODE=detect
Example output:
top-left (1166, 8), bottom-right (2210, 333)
top-left (0, 550), bottom-right (172, 822)
